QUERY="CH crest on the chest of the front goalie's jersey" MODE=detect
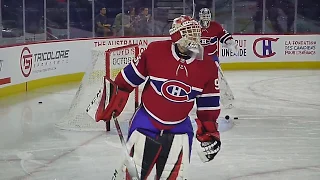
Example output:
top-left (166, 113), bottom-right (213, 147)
top-left (161, 80), bottom-right (191, 102)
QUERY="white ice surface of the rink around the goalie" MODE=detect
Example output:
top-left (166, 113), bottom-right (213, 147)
top-left (0, 70), bottom-right (320, 180)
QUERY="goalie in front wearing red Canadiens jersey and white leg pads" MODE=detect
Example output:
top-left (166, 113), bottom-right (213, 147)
top-left (96, 15), bottom-right (221, 180)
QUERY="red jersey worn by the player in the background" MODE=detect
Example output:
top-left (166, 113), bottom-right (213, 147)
top-left (201, 21), bottom-right (232, 56)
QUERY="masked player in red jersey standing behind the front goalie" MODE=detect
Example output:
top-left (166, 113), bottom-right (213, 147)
top-left (199, 8), bottom-right (239, 63)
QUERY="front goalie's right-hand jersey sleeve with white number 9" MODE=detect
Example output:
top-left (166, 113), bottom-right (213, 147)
top-left (196, 64), bottom-right (220, 125)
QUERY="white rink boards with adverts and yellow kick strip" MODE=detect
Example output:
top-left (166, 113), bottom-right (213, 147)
top-left (0, 35), bottom-right (320, 97)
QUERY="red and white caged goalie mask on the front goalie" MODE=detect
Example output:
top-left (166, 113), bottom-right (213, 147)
top-left (169, 15), bottom-right (201, 53)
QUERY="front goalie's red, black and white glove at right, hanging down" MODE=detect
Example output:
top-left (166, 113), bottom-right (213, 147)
top-left (196, 119), bottom-right (221, 162)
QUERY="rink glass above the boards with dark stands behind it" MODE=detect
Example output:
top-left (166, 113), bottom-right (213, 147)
top-left (0, 0), bottom-right (320, 45)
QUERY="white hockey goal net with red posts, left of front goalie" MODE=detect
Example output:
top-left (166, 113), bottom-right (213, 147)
top-left (55, 44), bottom-right (139, 131)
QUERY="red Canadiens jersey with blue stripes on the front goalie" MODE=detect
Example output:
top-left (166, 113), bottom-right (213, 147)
top-left (115, 40), bottom-right (220, 125)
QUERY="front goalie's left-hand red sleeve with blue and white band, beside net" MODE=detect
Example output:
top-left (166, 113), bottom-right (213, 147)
top-left (115, 49), bottom-right (148, 92)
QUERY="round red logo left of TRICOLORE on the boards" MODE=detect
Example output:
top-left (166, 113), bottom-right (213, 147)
top-left (20, 47), bottom-right (32, 77)
